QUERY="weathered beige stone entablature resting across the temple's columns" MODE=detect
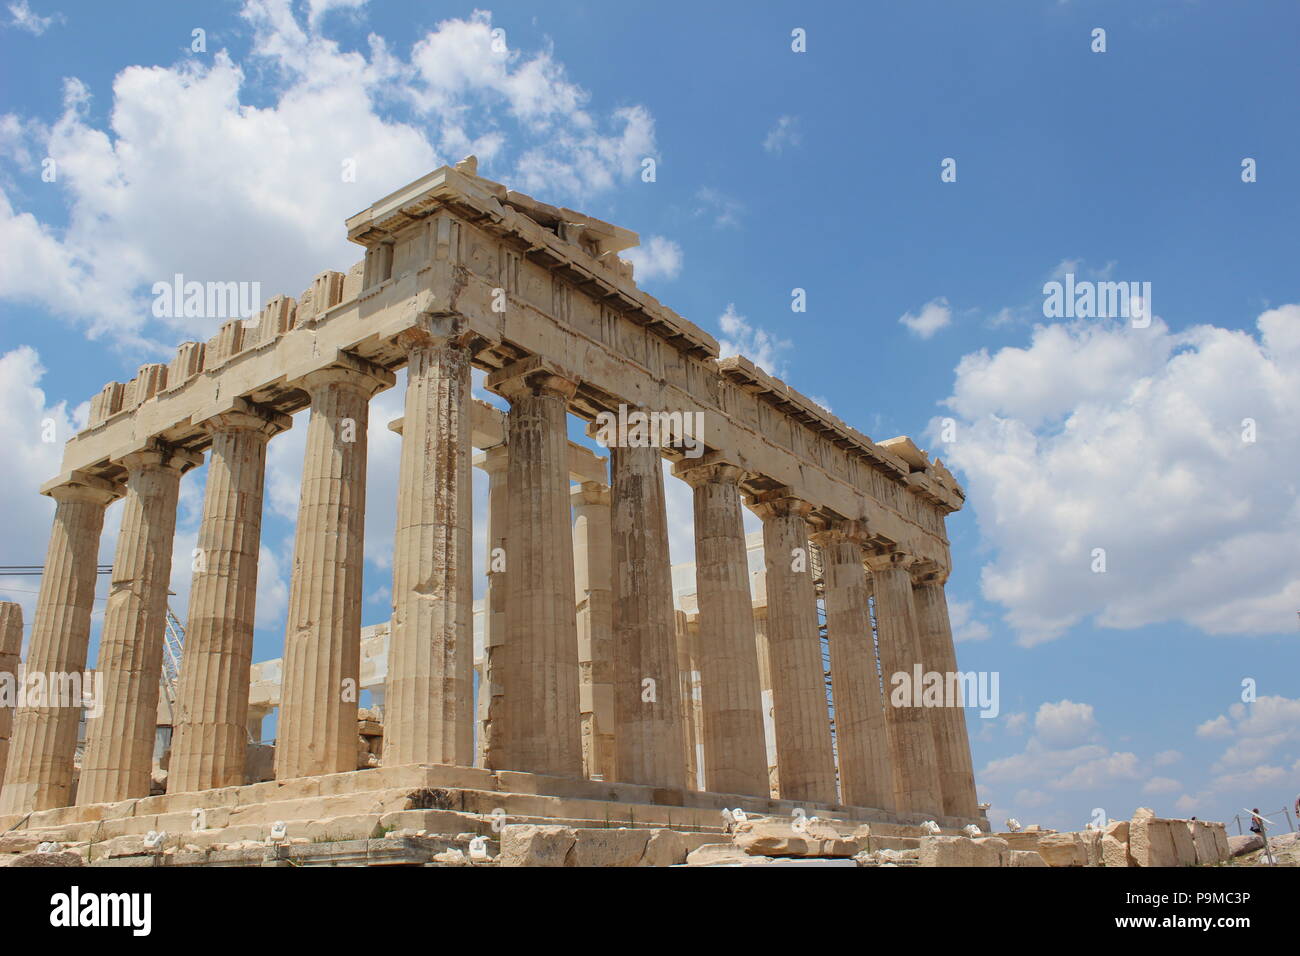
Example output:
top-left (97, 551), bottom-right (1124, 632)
top-left (51, 168), bottom-right (963, 566)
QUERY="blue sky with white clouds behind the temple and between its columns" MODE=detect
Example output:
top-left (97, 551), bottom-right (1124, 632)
top-left (0, 0), bottom-right (1300, 827)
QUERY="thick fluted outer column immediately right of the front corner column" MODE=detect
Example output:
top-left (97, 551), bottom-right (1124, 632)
top-left (486, 359), bottom-right (582, 777)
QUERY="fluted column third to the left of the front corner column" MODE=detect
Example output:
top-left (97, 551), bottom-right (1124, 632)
top-left (77, 442), bottom-right (203, 806)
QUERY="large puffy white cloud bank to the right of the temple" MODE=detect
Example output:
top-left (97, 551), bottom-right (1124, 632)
top-left (931, 306), bottom-right (1300, 645)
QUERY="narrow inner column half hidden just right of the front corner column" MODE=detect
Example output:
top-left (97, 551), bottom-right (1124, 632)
top-left (475, 444), bottom-right (510, 766)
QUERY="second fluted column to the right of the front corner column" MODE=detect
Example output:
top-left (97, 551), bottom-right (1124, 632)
top-left (610, 434), bottom-right (686, 790)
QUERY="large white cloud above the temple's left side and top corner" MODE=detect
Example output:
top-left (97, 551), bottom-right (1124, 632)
top-left (0, 0), bottom-right (654, 358)
